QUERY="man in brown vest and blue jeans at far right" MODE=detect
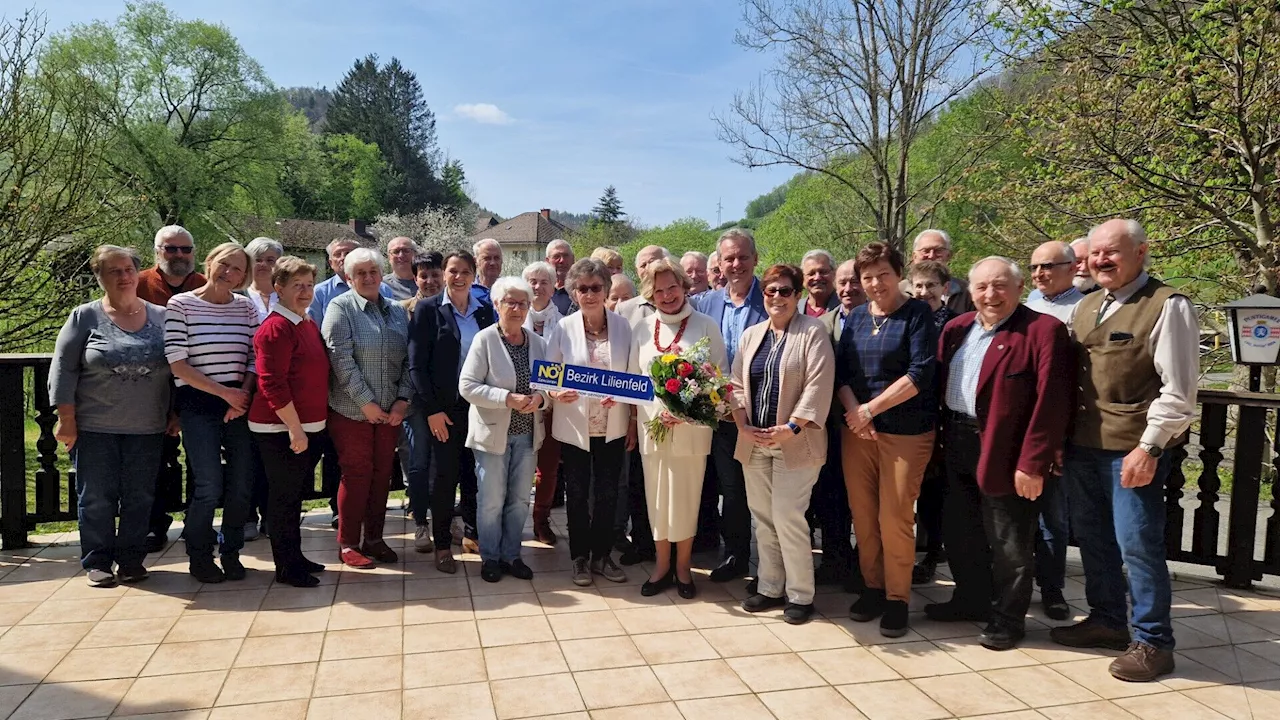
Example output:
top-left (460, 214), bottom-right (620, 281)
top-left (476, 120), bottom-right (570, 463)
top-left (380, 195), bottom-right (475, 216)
top-left (1051, 219), bottom-right (1199, 682)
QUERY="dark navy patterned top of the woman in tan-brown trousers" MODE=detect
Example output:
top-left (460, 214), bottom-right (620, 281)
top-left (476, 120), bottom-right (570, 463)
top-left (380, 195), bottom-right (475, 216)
top-left (836, 297), bottom-right (938, 436)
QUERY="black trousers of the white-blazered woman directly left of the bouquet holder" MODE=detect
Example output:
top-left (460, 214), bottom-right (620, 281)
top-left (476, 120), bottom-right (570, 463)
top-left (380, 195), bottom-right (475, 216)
top-left (561, 437), bottom-right (627, 560)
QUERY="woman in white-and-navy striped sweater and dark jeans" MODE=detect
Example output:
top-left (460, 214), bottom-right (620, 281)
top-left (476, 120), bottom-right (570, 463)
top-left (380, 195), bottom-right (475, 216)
top-left (164, 242), bottom-right (257, 583)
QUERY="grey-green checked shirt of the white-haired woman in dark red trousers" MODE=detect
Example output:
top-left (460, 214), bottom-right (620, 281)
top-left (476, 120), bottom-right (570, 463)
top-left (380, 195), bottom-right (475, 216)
top-left (321, 291), bottom-right (412, 421)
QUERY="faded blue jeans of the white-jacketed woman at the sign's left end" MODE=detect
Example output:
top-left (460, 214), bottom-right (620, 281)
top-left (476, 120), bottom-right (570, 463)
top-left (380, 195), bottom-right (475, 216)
top-left (475, 433), bottom-right (538, 562)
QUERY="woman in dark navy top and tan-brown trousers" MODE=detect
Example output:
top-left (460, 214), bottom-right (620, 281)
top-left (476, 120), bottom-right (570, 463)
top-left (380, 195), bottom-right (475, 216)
top-left (836, 242), bottom-right (938, 638)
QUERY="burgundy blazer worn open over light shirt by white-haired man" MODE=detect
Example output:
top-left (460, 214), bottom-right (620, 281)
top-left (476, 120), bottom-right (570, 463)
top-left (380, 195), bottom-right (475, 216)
top-left (938, 305), bottom-right (1075, 496)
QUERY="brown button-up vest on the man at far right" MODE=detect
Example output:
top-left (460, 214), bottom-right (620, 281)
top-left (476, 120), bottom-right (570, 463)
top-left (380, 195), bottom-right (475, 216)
top-left (1071, 278), bottom-right (1179, 452)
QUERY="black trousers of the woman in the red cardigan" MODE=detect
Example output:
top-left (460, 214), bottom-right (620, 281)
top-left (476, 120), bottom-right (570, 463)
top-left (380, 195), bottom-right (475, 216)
top-left (253, 433), bottom-right (324, 570)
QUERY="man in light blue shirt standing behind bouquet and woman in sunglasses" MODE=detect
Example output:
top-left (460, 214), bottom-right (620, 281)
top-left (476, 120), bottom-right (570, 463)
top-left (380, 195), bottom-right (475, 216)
top-left (692, 228), bottom-right (767, 583)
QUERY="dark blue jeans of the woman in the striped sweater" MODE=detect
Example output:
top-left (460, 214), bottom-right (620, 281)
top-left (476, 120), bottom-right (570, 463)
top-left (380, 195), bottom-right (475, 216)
top-left (178, 397), bottom-right (253, 560)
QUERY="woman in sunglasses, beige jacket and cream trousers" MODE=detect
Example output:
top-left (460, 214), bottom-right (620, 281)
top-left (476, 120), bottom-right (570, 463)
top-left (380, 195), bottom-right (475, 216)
top-left (730, 265), bottom-right (836, 625)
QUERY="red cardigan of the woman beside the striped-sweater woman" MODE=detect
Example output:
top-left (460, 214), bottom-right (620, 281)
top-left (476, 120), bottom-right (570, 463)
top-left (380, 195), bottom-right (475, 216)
top-left (248, 306), bottom-right (329, 432)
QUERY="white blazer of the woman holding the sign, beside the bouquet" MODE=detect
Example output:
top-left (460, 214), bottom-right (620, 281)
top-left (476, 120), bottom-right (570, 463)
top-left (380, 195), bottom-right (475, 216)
top-left (547, 310), bottom-right (631, 452)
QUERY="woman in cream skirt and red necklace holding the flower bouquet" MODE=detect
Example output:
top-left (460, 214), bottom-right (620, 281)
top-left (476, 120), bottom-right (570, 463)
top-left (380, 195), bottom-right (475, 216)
top-left (630, 258), bottom-right (727, 600)
